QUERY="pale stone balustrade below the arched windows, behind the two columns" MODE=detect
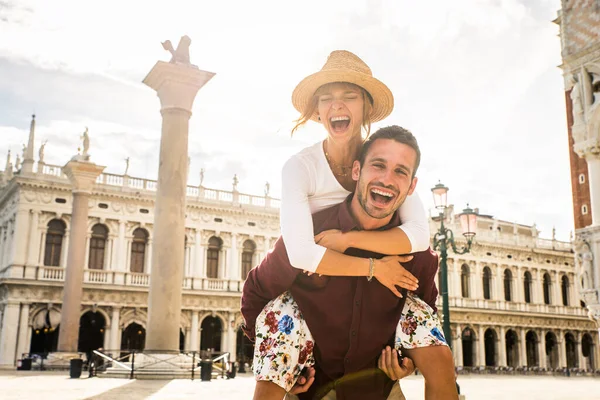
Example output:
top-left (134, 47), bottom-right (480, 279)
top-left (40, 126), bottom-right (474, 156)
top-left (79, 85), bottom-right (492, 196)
top-left (0, 266), bottom-right (244, 293)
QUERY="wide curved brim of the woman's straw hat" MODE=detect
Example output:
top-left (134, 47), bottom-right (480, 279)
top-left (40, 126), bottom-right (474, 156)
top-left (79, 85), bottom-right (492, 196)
top-left (292, 69), bottom-right (394, 122)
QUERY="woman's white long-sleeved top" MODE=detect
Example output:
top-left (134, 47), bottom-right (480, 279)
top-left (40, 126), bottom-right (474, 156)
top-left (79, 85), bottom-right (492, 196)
top-left (280, 142), bottom-right (429, 272)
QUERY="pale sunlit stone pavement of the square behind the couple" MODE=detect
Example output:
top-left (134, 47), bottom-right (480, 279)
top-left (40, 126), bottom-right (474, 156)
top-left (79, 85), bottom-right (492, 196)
top-left (0, 371), bottom-right (600, 400)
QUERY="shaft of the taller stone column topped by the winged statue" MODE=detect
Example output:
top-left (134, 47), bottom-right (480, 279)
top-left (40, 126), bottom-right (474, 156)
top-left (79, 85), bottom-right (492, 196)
top-left (146, 108), bottom-right (191, 352)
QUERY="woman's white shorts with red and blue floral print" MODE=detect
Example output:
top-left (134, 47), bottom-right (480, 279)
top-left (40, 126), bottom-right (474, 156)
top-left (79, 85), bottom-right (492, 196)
top-left (252, 292), bottom-right (447, 392)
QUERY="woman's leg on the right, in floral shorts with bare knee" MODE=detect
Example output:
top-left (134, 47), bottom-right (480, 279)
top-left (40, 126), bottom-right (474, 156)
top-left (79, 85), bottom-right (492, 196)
top-left (396, 294), bottom-right (458, 400)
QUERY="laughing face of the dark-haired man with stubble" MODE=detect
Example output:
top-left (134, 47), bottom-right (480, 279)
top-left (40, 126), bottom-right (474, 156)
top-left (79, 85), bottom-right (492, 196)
top-left (352, 139), bottom-right (417, 219)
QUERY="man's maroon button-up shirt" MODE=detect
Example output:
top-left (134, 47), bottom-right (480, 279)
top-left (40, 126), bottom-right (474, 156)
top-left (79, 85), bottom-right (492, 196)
top-left (242, 195), bottom-right (438, 400)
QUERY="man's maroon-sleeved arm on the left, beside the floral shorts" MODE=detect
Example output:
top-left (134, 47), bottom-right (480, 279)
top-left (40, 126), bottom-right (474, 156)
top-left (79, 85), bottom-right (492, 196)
top-left (241, 237), bottom-right (301, 340)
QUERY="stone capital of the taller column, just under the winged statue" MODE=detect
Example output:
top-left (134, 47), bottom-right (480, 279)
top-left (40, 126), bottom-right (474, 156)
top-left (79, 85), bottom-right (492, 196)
top-left (142, 61), bottom-right (215, 113)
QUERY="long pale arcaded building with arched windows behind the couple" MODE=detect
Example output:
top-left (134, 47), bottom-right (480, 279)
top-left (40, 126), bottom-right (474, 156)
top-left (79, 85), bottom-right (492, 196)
top-left (0, 117), bottom-right (600, 370)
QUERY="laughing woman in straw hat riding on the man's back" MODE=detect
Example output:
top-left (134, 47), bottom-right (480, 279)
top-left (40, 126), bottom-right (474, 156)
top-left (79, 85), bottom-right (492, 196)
top-left (255, 51), bottom-right (457, 399)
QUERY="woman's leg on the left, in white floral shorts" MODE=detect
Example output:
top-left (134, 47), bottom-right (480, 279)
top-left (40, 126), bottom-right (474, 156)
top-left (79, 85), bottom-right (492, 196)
top-left (252, 292), bottom-right (314, 400)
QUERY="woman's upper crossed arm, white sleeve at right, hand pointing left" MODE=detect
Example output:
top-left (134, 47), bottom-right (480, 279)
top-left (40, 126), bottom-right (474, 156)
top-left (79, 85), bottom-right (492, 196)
top-left (315, 193), bottom-right (430, 255)
